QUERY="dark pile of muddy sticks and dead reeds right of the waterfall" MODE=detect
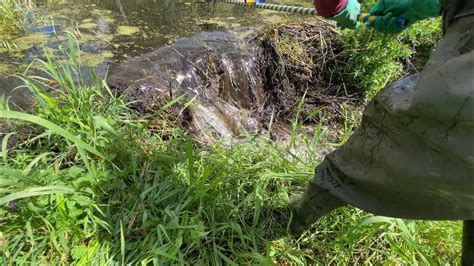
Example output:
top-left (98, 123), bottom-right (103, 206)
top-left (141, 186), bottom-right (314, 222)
top-left (259, 21), bottom-right (358, 127)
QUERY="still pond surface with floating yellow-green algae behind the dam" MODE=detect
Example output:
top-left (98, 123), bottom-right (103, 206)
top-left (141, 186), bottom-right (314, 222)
top-left (0, 0), bottom-right (281, 74)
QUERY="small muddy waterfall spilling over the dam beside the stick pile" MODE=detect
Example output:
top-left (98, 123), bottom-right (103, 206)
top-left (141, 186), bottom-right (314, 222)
top-left (109, 29), bottom-right (265, 142)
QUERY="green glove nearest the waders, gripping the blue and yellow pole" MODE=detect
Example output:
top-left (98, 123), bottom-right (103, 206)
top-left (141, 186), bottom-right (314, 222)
top-left (367, 0), bottom-right (441, 33)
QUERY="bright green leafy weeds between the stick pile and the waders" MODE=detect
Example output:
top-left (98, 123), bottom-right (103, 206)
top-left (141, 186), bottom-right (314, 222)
top-left (338, 10), bottom-right (442, 101)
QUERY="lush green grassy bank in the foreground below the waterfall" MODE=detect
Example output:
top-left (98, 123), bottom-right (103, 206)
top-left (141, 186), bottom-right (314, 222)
top-left (0, 29), bottom-right (461, 265)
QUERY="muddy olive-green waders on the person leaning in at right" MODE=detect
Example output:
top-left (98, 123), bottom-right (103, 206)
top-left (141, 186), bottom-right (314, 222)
top-left (291, 0), bottom-right (474, 265)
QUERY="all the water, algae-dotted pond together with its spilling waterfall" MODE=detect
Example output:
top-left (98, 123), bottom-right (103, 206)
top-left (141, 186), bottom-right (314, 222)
top-left (0, 0), bottom-right (316, 141)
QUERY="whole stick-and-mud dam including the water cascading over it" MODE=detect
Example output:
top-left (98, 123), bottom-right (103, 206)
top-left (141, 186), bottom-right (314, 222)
top-left (109, 21), bottom-right (356, 142)
